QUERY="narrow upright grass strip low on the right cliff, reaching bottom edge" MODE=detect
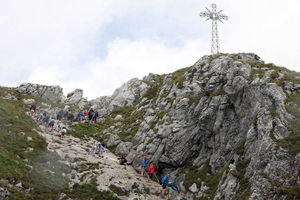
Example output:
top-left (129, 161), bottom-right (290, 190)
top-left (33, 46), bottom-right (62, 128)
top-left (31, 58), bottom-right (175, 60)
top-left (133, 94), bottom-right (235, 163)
top-left (230, 159), bottom-right (251, 200)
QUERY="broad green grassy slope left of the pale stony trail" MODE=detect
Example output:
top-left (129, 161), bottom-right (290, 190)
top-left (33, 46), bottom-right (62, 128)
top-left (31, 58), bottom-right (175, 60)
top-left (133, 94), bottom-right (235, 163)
top-left (0, 88), bottom-right (69, 200)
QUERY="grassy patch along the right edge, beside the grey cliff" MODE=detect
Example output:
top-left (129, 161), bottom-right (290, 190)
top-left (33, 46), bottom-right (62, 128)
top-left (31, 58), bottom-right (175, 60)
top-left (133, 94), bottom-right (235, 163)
top-left (278, 93), bottom-right (300, 155)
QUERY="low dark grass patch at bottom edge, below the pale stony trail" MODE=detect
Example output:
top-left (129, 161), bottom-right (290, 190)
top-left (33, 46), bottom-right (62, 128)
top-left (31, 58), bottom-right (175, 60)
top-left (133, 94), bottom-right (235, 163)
top-left (65, 184), bottom-right (119, 200)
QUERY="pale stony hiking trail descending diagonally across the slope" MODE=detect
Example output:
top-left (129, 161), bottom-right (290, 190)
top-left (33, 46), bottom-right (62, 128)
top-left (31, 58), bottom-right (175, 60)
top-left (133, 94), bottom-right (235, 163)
top-left (39, 121), bottom-right (180, 200)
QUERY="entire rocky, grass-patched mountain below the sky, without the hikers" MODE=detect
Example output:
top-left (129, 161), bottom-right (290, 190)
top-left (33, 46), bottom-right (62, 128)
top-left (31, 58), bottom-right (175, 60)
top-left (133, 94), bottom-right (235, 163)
top-left (0, 53), bottom-right (300, 200)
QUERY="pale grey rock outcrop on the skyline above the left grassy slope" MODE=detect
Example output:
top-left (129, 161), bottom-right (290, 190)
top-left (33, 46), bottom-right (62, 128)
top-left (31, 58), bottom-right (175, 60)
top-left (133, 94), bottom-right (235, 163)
top-left (16, 83), bottom-right (65, 103)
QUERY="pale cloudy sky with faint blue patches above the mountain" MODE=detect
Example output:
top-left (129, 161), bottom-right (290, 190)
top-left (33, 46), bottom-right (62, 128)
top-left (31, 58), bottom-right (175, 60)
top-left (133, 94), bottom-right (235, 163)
top-left (0, 0), bottom-right (300, 99)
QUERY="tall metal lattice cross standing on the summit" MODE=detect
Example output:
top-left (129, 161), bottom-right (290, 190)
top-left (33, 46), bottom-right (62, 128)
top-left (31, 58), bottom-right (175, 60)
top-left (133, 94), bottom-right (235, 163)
top-left (199, 3), bottom-right (228, 54)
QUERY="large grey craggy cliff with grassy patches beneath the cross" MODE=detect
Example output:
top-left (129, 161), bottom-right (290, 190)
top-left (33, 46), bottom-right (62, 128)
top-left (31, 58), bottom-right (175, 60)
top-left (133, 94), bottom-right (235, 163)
top-left (95, 54), bottom-right (300, 199)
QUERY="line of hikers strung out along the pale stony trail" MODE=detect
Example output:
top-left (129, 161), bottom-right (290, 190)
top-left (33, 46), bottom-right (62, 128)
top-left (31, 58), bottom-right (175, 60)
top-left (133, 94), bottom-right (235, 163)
top-left (29, 105), bottom-right (180, 199)
